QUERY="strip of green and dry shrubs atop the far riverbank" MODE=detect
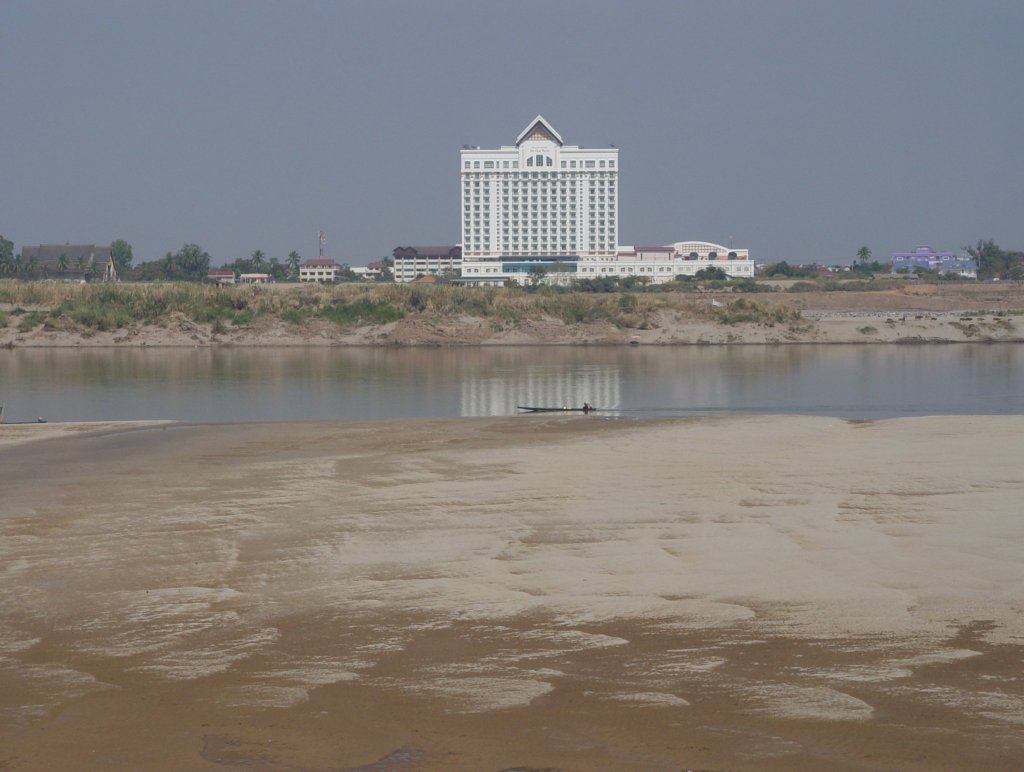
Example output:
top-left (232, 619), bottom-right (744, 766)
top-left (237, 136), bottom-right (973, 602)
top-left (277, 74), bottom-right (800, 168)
top-left (0, 281), bottom-right (800, 334)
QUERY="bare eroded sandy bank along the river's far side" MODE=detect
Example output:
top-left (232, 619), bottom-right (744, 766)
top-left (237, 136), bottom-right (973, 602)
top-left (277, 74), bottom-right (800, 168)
top-left (0, 283), bottom-right (1024, 348)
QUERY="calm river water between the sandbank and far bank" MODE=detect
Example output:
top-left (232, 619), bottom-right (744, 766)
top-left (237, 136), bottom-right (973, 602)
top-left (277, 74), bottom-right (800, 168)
top-left (0, 344), bottom-right (1024, 422)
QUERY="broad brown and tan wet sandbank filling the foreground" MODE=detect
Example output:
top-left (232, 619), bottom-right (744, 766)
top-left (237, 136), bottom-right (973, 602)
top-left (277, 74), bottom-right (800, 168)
top-left (0, 416), bottom-right (1024, 770)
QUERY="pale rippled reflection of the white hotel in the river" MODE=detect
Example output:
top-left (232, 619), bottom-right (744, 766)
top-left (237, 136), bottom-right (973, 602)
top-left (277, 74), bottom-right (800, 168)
top-left (462, 366), bottom-right (622, 416)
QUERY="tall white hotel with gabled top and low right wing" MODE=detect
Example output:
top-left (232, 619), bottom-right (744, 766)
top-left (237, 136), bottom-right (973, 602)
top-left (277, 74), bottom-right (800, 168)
top-left (459, 116), bottom-right (754, 286)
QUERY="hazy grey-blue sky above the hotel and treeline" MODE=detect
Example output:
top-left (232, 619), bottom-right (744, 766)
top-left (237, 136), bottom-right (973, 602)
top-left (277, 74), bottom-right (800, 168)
top-left (0, 0), bottom-right (1024, 265)
